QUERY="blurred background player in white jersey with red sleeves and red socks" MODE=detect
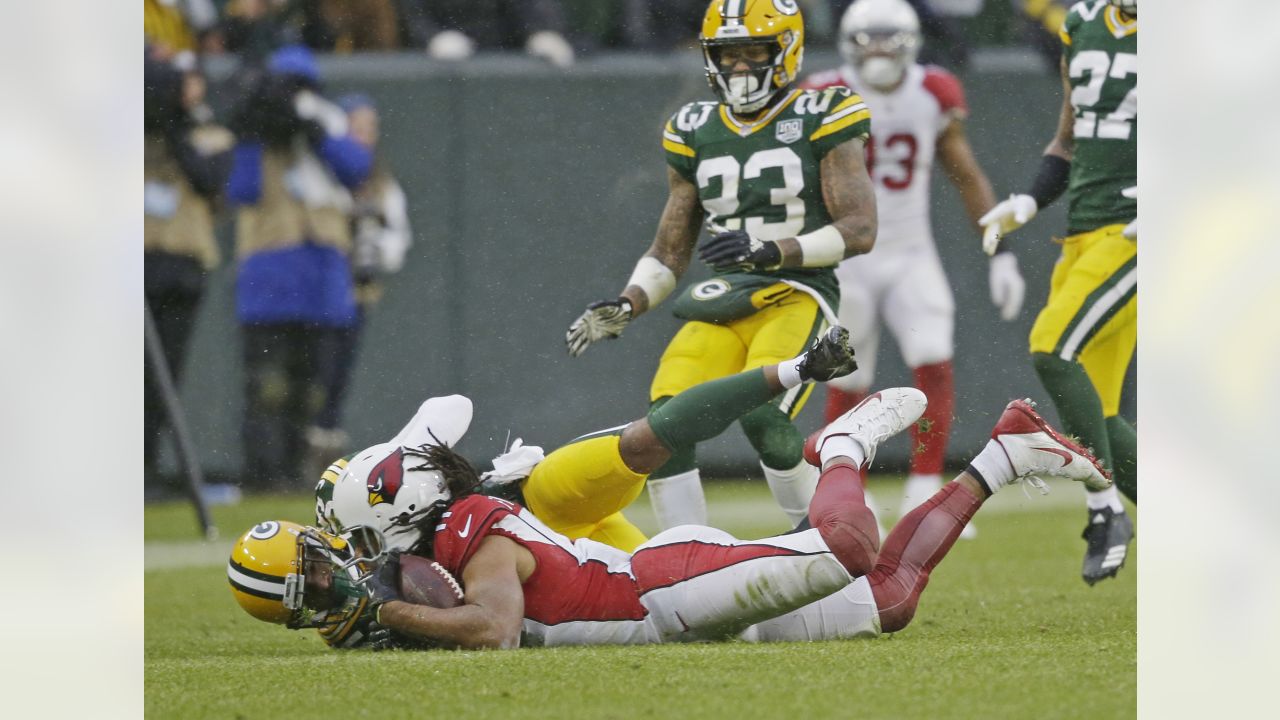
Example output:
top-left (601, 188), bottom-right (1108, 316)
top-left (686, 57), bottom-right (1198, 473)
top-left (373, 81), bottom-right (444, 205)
top-left (804, 0), bottom-right (1025, 527)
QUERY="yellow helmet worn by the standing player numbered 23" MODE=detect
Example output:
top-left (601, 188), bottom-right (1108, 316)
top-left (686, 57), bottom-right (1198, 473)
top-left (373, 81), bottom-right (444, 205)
top-left (700, 0), bottom-right (804, 113)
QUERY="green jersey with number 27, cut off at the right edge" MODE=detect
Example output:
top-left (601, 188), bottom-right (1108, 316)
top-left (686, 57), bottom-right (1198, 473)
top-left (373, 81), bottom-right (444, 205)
top-left (1060, 0), bottom-right (1138, 234)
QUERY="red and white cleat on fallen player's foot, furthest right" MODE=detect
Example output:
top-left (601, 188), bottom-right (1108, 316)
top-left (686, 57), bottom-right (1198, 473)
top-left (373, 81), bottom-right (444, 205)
top-left (991, 400), bottom-right (1111, 492)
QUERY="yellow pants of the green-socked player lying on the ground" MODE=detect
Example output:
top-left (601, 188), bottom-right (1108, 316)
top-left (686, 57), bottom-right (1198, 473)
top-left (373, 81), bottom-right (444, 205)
top-left (524, 433), bottom-right (648, 552)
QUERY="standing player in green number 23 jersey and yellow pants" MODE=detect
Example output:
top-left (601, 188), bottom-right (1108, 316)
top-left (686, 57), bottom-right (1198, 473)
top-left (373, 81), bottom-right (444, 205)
top-left (566, 0), bottom-right (877, 528)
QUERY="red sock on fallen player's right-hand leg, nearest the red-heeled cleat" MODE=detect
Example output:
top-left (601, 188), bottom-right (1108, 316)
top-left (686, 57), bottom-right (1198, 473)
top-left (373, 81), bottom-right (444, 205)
top-left (870, 482), bottom-right (986, 633)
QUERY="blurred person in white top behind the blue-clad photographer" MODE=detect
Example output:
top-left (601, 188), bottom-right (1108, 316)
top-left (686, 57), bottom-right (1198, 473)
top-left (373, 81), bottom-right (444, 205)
top-left (305, 94), bottom-right (413, 479)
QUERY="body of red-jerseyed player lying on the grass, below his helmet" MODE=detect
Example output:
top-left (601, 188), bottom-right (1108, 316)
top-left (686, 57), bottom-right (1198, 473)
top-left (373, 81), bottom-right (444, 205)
top-left (353, 389), bottom-right (1110, 648)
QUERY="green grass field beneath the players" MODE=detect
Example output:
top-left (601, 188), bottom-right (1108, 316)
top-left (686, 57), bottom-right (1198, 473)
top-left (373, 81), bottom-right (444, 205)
top-left (145, 478), bottom-right (1137, 720)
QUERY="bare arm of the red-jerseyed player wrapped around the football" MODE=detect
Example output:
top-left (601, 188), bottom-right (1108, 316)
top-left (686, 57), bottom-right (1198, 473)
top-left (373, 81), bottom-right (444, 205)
top-left (378, 536), bottom-right (535, 650)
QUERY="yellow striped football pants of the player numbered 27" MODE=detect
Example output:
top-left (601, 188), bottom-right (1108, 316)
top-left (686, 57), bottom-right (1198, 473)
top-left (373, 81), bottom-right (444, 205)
top-left (1030, 224), bottom-right (1138, 418)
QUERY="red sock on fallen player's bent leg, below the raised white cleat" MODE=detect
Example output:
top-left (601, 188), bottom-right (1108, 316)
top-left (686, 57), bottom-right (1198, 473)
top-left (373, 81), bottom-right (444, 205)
top-left (809, 465), bottom-right (879, 578)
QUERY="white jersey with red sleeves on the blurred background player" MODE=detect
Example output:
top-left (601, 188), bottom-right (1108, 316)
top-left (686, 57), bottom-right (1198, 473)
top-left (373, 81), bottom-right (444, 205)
top-left (804, 64), bottom-right (968, 256)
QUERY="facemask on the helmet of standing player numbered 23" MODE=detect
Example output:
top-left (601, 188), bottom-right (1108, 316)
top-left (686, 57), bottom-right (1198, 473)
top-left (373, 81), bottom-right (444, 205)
top-left (701, 28), bottom-right (797, 114)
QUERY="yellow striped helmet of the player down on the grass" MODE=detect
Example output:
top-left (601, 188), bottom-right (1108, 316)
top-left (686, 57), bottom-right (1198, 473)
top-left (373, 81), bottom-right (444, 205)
top-left (227, 520), bottom-right (379, 629)
